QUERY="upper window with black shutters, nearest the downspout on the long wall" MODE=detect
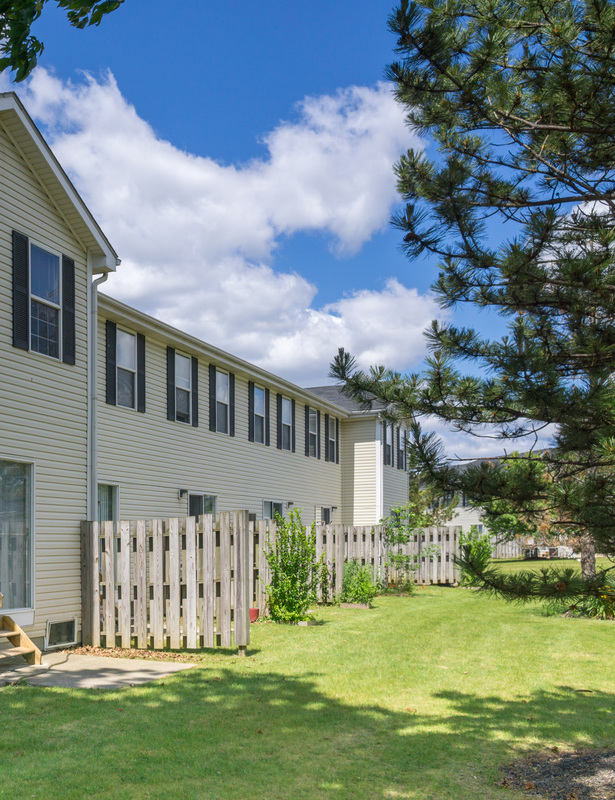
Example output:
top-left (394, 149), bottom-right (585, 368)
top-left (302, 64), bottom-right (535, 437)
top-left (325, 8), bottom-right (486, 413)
top-left (105, 320), bottom-right (145, 413)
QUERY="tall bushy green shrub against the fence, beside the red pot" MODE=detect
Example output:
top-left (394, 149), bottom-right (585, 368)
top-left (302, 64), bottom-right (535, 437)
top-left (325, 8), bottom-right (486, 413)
top-left (266, 508), bottom-right (319, 622)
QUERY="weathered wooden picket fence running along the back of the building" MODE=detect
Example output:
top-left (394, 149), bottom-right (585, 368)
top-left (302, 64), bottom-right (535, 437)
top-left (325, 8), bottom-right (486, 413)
top-left (81, 511), bottom-right (520, 651)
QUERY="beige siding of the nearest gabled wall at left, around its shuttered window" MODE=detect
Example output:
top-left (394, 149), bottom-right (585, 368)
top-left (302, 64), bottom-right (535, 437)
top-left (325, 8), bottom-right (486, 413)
top-left (0, 123), bottom-right (87, 638)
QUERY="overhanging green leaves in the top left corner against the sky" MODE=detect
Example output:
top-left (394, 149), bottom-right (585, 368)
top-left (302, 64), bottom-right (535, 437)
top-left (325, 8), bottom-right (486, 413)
top-left (0, 0), bottom-right (124, 81)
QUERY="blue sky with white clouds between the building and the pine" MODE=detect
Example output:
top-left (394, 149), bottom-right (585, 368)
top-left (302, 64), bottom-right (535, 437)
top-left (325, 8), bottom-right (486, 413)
top-left (0, 0), bottom-right (528, 454)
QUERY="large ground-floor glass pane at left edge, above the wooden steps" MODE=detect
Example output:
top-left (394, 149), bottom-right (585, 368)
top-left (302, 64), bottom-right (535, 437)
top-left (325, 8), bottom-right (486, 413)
top-left (0, 460), bottom-right (33, 610)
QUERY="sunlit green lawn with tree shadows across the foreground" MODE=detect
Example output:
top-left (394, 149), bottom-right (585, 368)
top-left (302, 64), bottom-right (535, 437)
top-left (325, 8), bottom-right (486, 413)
top-left (0, 587), bottom-right (615, 800)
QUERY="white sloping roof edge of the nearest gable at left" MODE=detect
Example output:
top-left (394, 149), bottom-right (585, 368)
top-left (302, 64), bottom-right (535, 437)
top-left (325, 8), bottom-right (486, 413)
top-left (0, 92), bottom-right (120, 273)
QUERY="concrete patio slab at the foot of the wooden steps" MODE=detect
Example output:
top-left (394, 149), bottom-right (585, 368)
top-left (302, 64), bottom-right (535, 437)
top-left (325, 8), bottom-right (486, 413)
top-left (0, 653), bottom-right (195, 689)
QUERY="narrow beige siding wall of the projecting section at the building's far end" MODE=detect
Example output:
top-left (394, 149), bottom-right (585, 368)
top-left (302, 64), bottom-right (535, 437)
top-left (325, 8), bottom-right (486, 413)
top-left (341, 416), bottom-right (382, 525)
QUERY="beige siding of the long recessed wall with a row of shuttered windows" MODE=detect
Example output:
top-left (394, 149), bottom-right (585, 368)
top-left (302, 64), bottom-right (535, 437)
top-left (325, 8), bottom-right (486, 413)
top-left (98, 316), bottom-right (341, 522)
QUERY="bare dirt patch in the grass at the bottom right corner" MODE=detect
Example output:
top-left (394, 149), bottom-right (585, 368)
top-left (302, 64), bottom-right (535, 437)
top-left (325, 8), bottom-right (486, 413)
top-left (500, 748), bottom-right (615, 800)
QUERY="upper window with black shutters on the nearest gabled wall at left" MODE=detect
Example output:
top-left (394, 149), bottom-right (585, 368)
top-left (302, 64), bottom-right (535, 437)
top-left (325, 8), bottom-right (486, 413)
top-left (13, 231), bottom-right (75, 364)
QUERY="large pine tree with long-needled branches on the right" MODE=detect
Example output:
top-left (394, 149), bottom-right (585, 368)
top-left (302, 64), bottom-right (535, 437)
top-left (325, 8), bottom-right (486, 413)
top-left (332, 0), bottom-right (615, 597)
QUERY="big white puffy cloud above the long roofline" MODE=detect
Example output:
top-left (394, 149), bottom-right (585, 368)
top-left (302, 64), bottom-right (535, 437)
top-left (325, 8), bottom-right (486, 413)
top-left (6, 69), bottom-right (438, 385)
